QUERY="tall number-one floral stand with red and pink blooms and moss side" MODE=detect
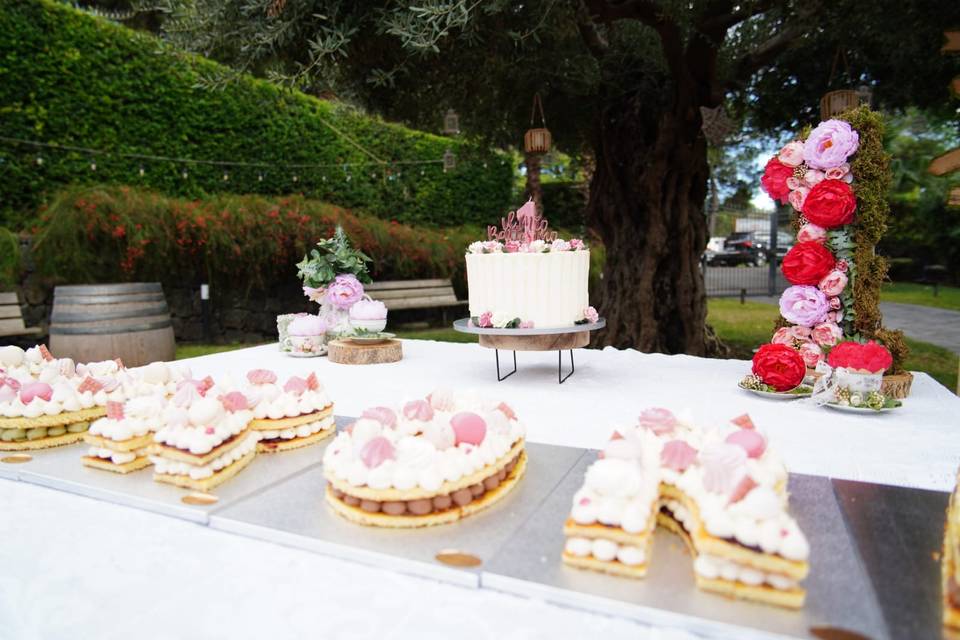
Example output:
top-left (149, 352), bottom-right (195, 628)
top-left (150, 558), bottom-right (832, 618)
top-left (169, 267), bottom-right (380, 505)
top-left (761, 107), bottom-right (906, 382)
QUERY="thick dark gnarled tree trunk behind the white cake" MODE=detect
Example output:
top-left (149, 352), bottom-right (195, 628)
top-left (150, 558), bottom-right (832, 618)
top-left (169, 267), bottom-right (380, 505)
top-left (588, 89), bottom-right (716, 355)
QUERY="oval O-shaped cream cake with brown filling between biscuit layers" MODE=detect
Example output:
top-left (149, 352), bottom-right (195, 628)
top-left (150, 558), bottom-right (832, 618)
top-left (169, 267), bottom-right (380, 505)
top-left (323, 390), bottom-right (526, 527)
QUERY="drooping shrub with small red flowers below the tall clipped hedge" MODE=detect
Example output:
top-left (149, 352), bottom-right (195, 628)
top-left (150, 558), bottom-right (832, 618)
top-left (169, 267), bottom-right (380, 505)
top-left (33, 187), bottom-right (481, 290)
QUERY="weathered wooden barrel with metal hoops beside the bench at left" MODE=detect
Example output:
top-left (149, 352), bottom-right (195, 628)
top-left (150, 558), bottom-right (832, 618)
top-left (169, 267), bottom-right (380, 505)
top-left (50, 282), bottom-right (176, 367)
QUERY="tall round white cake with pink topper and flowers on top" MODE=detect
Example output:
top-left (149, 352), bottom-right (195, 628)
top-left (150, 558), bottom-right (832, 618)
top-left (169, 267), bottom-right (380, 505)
top-left (466, 201), bottom-right (592, 329)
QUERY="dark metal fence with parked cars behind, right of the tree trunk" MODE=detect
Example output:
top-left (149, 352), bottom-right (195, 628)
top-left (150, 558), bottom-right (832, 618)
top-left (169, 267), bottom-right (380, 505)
top-left (700, 207), bottom-right (795, 296)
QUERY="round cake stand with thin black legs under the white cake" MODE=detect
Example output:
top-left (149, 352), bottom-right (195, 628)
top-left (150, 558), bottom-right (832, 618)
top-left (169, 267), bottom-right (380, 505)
top-left (453, 318), bottom-right (607, 384)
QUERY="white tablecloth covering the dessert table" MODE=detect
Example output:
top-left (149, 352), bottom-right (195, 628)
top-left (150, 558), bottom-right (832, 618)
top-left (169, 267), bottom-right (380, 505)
top-left (0, 341), bottom-right (960, 640)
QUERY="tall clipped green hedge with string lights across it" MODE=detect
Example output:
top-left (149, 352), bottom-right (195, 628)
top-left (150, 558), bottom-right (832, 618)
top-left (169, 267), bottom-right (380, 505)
top-left (0, 0), bottom-right (513, 228)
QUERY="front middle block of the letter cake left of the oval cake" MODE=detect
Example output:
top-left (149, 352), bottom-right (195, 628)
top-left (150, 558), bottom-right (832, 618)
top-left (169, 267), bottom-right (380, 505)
top-left (148, 381), bottom-right (260, 491)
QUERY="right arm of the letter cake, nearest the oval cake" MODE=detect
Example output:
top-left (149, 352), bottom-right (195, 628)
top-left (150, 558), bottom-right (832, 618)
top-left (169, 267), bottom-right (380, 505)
top-left (242, 369), bottom-right (337, 453)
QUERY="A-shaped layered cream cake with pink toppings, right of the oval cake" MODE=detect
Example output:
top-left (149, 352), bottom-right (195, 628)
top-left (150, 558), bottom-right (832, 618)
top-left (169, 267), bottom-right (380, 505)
top-left (563, 409), bottom-right (810, 608)
